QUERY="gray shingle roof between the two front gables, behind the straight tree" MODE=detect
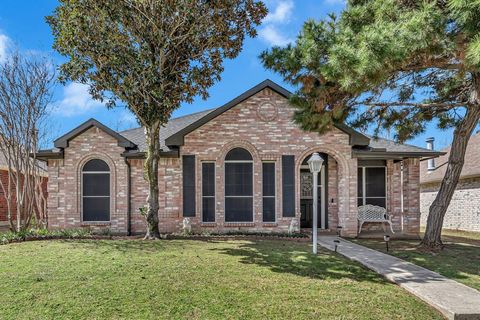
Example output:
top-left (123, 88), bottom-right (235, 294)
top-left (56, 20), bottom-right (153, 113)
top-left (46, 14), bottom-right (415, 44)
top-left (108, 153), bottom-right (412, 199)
top-left (119, 109), bottom-right (215, 152)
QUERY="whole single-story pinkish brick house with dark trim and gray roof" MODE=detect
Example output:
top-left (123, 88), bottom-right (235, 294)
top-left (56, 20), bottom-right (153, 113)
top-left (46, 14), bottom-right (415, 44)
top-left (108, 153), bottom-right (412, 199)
top-left (38, 80), bottom-right (438, 236)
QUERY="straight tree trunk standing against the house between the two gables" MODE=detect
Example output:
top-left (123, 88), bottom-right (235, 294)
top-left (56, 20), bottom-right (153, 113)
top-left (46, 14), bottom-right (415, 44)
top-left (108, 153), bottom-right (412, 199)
top-left (145, 122), bottom-right (160, 239)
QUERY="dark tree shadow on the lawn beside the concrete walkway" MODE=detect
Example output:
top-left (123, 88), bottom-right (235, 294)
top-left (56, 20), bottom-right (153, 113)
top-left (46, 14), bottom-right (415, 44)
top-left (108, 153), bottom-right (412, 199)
top-left (210, 240), bottom-right (387, 284)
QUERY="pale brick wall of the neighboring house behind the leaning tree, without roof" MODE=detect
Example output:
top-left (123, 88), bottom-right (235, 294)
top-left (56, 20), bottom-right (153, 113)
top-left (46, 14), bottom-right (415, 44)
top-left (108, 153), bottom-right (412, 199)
top-left (420, 177), bottom-right (480, 231)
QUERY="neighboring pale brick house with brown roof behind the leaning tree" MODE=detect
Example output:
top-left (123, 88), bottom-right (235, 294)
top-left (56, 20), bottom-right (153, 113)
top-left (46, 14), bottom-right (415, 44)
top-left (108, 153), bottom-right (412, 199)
top-left (420, 133), bottom-right (480, 231)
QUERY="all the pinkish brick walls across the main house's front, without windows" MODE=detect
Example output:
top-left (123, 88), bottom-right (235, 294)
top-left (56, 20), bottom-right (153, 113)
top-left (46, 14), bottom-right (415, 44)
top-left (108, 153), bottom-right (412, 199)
top-left (44, 89), bottom-right (419, 236)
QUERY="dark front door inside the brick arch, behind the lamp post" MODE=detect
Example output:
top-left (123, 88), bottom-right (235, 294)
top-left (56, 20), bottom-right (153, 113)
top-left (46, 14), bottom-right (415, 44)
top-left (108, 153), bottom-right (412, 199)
top-left (300, 166), bottom-right (328, 228)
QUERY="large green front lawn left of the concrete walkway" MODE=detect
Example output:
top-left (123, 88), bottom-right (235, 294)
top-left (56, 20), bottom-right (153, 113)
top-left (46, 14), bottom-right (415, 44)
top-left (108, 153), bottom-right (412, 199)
top-left (0, 240), bottom-right (442, 319)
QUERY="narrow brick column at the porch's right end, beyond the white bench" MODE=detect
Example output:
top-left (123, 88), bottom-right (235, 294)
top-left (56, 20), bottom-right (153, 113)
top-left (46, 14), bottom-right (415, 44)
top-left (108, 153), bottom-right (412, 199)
top-left (403, 158), bottom-right (420, 235)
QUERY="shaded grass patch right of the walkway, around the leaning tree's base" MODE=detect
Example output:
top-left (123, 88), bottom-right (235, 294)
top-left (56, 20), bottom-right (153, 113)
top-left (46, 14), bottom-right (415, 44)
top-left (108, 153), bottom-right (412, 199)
top-left (355, 230), bottom-right (480, 290)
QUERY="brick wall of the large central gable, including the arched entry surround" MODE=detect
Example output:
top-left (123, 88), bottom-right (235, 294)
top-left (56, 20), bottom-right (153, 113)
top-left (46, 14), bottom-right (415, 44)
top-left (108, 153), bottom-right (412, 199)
top-left (154, 89), bottom-right (357, 235)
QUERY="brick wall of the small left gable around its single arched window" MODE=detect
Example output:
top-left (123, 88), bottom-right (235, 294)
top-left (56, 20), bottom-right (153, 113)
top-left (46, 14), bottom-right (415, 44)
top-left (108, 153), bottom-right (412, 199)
top-left (48, 127), bottom-right (128, 234)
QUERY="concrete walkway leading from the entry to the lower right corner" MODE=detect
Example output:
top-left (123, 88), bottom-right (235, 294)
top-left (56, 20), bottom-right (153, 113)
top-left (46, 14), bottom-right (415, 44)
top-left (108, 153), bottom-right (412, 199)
top-left (318, 236), bottom-right (480, 320)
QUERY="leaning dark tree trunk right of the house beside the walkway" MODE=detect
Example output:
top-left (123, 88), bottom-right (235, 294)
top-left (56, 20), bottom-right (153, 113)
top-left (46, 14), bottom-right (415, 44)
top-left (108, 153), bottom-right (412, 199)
top-left (421, 74), bottom-right (480, 250)
